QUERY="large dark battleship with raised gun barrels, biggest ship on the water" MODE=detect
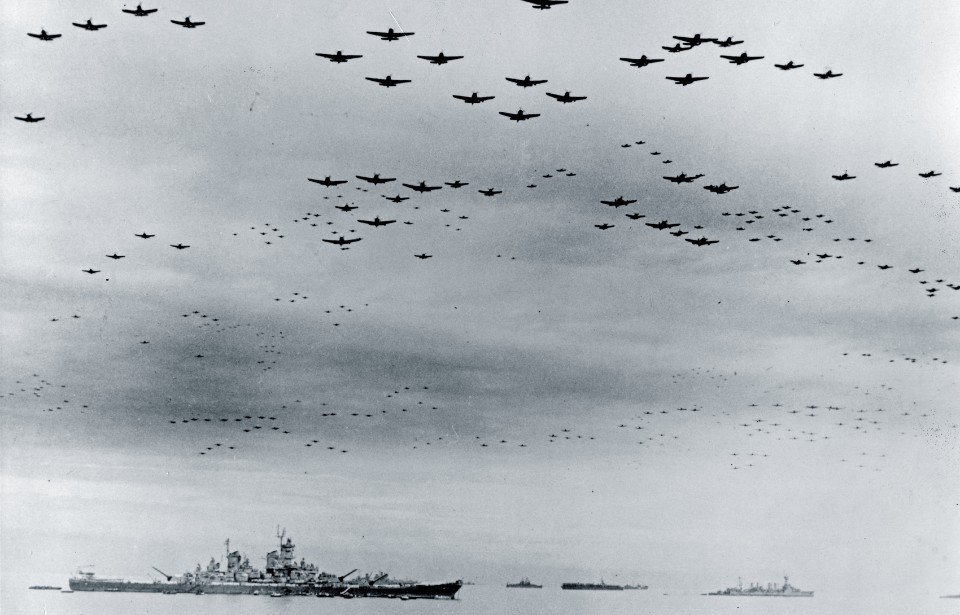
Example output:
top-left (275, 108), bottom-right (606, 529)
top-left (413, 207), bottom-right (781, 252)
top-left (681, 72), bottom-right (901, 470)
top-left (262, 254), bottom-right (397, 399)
top-left (70, 532), bottom-right (463, 600)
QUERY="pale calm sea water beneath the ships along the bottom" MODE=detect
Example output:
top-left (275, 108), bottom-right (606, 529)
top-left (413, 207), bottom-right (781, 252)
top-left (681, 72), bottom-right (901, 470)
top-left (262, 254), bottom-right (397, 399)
top-left (2, 583), bottom-right (960, 615)
